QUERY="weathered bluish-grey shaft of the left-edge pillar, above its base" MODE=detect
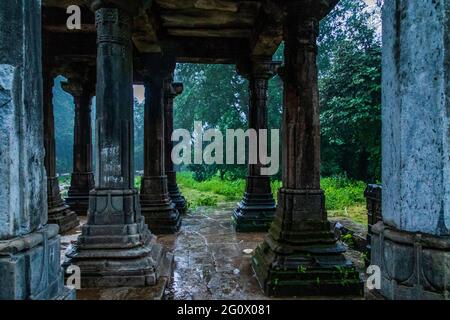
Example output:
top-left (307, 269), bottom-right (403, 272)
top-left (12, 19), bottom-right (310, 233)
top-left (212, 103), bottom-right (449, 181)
top-left (0, 0), bottom-right (47, 239)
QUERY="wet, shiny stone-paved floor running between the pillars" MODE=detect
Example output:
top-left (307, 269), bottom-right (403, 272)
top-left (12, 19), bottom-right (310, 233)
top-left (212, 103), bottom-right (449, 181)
top-left (61, 203), bottom-right (362, 300)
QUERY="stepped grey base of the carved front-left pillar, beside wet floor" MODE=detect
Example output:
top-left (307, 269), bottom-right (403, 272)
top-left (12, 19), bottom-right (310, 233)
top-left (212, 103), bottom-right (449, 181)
top-left (64, 190), bottom-right (173, 289)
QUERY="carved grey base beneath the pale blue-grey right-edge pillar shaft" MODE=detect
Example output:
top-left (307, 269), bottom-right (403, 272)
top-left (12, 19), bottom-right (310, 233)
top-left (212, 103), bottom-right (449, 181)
top-left (371, 222), bottom-right (450, 300)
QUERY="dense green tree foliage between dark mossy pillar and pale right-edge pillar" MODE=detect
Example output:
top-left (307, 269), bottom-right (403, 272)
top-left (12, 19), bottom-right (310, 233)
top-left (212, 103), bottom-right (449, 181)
top-left (318, 0), bottom-right (381, 182)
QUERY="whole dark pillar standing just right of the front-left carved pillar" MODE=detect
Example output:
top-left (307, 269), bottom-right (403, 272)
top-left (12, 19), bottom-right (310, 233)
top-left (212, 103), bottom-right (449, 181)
top-left (140, 54), bottom-right (181, 234)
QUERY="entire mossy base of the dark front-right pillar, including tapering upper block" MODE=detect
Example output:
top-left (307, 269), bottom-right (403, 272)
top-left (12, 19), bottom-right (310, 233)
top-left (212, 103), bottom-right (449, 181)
top-left (252, 189), bottom-right (363, 297)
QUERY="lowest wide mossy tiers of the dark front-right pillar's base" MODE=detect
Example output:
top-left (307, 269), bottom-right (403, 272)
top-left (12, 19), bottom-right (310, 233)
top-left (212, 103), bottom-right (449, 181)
top-left (252, 236), bottom-right (363, 297)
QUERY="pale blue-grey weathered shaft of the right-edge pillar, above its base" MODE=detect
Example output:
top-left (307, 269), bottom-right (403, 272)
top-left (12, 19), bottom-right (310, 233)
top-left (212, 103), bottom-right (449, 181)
top-left (382, 0), bottom-right (450, 235)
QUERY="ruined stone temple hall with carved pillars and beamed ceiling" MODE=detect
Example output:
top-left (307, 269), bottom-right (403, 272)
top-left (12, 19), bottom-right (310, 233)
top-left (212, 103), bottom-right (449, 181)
top-left (0, 0), bottom-right (450, 299)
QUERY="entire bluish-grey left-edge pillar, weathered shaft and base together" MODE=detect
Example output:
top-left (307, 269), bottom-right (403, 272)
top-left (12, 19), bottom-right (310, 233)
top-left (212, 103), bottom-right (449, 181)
top-left (0, 0), bottom-right (75, 300)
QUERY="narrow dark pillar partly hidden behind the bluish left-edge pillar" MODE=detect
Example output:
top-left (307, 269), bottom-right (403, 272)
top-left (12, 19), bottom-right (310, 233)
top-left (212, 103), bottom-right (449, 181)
top-left (43, 68), bottom-right (79, 233)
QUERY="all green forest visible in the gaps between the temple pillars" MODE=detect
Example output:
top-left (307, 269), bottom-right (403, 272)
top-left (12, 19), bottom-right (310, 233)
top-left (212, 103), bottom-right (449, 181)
top-left (54, 0), bottom-right (381, 182)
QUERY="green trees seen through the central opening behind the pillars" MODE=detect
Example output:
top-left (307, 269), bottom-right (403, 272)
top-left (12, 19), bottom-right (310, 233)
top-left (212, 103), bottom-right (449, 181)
top-left (174, 64), bottom-right (282, 181)
